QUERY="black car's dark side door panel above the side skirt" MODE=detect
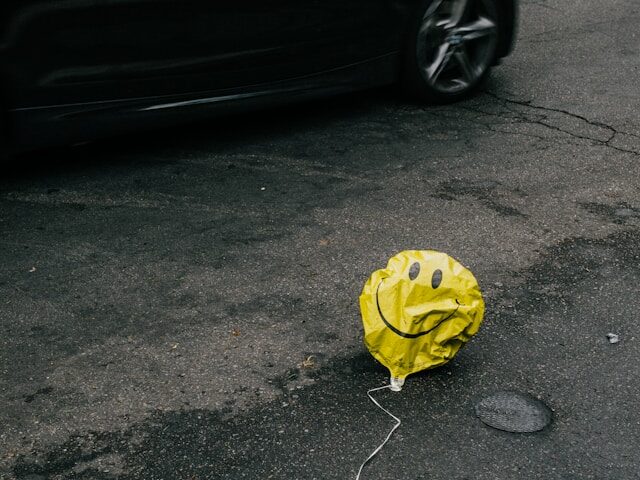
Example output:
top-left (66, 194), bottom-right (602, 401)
top-left (0, 0), bottom-right (400, 108)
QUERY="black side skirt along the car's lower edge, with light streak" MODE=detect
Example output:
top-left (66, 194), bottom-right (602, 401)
top-left (8, 52), bottom-right (398, 152)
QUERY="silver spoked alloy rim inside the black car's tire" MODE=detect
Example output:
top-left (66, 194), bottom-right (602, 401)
top-left (416, 0), bottom-right (498, 94)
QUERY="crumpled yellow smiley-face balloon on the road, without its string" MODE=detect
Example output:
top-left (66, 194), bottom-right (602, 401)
top-left (360, 250), bottom-right (484, 379)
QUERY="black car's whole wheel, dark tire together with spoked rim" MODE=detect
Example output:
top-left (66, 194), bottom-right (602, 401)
top-left (402, 0), bottom-right (500, 103)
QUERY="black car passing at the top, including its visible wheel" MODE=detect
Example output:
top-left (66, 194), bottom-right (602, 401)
top-left (0, 0), bottom-right (517, 149)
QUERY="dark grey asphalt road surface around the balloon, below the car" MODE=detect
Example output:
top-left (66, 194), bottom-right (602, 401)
top-left (0, 0), bottom-right (640, 480)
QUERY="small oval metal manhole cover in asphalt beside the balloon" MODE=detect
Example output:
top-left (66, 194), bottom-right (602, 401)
top-left (475, 392), bottom-right (553, 433)
